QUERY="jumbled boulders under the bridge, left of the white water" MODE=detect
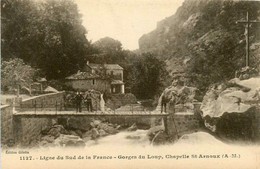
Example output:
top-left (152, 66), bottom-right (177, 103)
top-left (37, 119), bottom-right (141, 147)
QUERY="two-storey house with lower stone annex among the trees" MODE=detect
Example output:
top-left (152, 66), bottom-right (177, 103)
top-left (66, 62), bottom-right (125, 94)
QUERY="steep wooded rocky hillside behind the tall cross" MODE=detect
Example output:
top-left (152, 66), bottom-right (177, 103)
top-left (139, 0), bottom-right (260, 90)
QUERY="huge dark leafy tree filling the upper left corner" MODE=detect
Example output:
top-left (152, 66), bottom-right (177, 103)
top-left (1, 0), bottom-right (90, 79)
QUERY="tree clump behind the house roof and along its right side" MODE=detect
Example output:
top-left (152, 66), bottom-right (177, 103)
top-left (92, 37), bottom-right (169, 99)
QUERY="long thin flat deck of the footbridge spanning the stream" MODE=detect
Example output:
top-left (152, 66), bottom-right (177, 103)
top-left (13, 111), bottom-right (169, 116)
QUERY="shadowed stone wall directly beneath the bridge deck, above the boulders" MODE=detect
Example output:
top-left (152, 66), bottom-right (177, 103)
top-left (11, 113), bottom-right (168, 147)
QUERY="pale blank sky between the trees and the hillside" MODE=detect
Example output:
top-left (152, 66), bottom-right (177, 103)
top-left (74, 0), bottom-right (184, 50)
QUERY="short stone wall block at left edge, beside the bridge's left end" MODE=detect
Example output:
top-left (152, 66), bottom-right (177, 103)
top-left (1, 105), bottom-right (14, 145)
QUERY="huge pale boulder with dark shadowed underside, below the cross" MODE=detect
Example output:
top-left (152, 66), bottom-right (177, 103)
top-left (201, 77), bottom-right (260, 141)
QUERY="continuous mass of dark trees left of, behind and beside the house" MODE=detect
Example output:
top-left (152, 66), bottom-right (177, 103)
top-left (1, 0), bottom-right (171, 99)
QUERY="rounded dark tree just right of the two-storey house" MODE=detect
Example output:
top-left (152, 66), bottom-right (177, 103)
top-left (127, 53), bottom-right (169, 99)
